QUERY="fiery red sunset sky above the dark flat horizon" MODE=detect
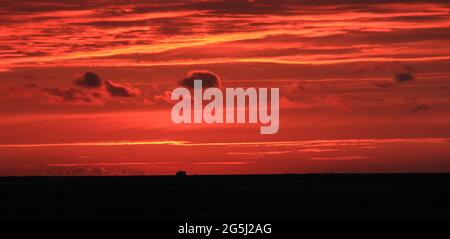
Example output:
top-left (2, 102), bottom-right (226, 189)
top-left (0, 0), bottom-right (450, 175)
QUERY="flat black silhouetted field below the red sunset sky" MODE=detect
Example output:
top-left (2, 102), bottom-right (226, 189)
top-left (0, 174), bottom-right (450, 219)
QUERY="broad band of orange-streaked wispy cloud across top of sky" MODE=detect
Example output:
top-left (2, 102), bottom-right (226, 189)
top-left (0, 1), bottom-right (450, 69)
